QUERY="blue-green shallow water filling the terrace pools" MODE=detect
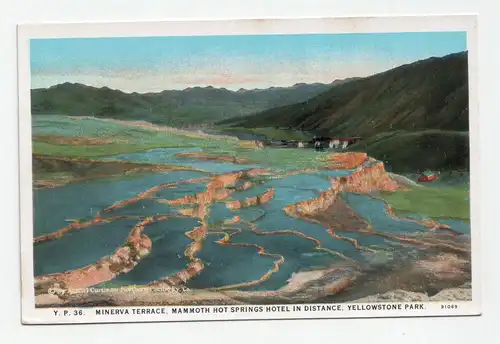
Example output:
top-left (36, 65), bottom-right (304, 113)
top-left (34, 119), bottom-right (470, 290)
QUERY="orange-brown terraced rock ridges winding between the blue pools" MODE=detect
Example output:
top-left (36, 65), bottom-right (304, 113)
top-left (35, 153), bottom-right (470, 306)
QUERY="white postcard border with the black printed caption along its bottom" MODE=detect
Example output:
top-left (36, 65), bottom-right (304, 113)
top-left (18, 14), bottom-right (481, 324)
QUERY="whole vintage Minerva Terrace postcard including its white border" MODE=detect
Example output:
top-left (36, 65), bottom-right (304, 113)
top-left (18, 15), bottom-right (481, 324)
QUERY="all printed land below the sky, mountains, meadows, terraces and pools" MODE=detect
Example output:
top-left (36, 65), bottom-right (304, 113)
top-left (31, 32), bottom-right (471, 307)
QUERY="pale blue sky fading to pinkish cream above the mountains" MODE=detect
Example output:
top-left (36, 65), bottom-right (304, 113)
top-left (31, 32), bottom-right (466, 92)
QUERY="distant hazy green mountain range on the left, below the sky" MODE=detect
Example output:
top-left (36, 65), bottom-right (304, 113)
top-left (31, 79), bottom-right (352, 126)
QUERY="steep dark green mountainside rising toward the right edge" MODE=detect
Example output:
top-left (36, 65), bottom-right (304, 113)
top-left (218, 52), bottom-right (469, 137)
